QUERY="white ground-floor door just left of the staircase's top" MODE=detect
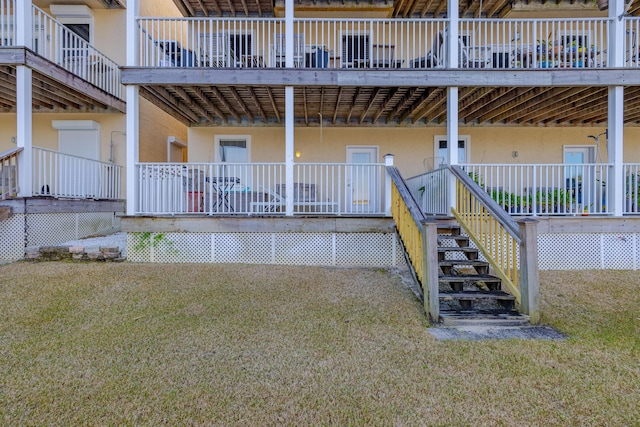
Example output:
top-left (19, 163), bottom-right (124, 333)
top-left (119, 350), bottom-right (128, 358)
top-left (345, 146), bottom-right (382, 213)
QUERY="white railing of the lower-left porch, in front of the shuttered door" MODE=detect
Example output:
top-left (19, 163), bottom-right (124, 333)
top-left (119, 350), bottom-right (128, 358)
top-left (32, 147), bottom-right (122, 199)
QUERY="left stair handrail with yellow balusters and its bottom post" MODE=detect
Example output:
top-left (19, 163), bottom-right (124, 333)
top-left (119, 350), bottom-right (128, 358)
top-left (386, 166), bottom-right (440, 322)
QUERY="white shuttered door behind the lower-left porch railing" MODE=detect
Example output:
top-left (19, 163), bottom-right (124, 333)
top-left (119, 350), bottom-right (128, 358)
top-left (59, 129), bottom-right (100, 197)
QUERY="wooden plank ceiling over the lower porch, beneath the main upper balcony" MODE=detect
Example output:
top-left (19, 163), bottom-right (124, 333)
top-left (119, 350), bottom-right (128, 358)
top-left (141, 85), bottom-right (640, 127)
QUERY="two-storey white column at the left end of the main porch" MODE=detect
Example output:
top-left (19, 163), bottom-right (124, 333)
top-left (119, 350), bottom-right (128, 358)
top-left (125, 0), bottom-right (140, 216)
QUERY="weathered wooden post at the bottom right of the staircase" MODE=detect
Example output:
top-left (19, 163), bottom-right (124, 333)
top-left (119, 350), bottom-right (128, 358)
top-left (518, 218), bottom-right (540, 325)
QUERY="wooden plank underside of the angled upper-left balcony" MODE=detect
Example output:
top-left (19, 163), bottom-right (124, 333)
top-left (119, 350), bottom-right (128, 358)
top-left (0, 65), bottom-right (122, 113)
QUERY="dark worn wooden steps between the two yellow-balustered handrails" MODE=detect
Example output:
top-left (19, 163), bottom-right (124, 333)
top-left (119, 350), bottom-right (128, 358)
top-left (437, 220), bottom-right (529, 326)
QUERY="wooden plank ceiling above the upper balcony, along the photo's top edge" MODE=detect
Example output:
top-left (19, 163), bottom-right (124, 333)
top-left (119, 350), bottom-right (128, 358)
top-left (173, 0), bottom-right (640, 18)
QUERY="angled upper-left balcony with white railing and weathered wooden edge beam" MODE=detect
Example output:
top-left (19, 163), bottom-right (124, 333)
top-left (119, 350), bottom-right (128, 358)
top-left (0, 0), bottom-right (124, 110)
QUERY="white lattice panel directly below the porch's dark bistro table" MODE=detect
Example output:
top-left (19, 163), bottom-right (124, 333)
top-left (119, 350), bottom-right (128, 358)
top-left (213, 233), bottom-right (272, 264)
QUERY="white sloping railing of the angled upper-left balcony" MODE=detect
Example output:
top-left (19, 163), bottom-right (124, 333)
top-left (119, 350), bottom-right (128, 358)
top-left (32, 6), bottom-right (122, 98)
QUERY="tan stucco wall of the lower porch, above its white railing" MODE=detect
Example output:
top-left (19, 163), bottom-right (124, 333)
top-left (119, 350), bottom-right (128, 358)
top-left (189, 127), bottom-right (640, 176)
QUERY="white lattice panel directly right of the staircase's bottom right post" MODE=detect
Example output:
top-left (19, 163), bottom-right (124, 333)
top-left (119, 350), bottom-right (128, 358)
top-left (538, 233), bottom-right (602, 270)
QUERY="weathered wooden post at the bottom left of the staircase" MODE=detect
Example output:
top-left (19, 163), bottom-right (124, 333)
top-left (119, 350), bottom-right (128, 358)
top-left (420, 219), bottom-right (440, 323)
